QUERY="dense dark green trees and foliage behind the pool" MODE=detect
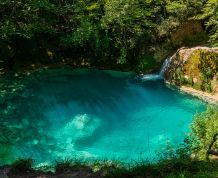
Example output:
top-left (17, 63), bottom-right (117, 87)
top-left (0, 0), bottom-right (218, 72)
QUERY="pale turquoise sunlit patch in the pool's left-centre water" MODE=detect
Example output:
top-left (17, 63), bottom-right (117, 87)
top-left (53, 114), bottom-right (101, 159)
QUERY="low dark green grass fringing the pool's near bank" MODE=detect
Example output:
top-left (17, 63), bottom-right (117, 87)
top-left (5, 150), bottom-right (218, 178)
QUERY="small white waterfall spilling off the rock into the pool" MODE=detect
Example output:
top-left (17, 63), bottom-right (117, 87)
top-left (141, 58), bottom-right (171, 80)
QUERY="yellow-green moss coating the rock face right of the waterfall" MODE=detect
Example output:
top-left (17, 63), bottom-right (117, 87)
top-left (171, 49), bottom-right (218, 92)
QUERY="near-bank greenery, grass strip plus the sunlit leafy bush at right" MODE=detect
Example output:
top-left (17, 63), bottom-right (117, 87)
top-left (2, 106), bottom-right (218, 178)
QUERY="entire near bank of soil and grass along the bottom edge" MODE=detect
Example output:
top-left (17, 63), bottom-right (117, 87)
top-left (0, 155), bottom-right (218, 178)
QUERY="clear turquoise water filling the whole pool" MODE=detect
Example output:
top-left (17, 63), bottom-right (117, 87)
top-left (0, 69), bottom-right (206, 164)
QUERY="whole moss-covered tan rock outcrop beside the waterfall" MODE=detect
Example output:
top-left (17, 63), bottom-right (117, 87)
top-left (164, 47), bottom-right (218, 92)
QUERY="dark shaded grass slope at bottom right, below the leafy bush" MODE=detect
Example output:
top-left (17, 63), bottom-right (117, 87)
top-left (106, 160), bottom-right (218, 178)
